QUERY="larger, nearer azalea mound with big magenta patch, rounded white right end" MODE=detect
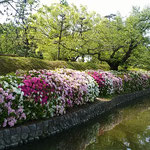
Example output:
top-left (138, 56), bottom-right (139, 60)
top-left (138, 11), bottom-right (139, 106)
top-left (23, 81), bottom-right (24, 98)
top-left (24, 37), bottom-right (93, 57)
top-left (0, 69), bottom-right (99, 127)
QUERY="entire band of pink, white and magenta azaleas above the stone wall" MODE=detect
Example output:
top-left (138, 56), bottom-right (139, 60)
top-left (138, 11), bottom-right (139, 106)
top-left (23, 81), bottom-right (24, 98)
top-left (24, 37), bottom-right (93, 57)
top-left (0, 69), bottom-right (150, 127)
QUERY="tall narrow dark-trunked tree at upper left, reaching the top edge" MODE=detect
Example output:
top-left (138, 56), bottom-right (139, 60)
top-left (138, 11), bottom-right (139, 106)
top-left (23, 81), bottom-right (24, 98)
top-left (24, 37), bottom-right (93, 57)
top-left (15, 0), bottom-right (38, 57)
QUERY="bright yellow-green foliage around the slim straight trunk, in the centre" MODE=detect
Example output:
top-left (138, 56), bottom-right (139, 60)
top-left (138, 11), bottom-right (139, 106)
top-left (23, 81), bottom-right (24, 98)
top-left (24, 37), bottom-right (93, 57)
top-left (31, 4), bottom-right (100, 61)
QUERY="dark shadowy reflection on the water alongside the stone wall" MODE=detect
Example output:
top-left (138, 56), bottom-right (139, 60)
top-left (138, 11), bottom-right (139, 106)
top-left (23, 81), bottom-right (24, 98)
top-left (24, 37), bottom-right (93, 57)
top-left (15, 123), bottom-right (99, 150)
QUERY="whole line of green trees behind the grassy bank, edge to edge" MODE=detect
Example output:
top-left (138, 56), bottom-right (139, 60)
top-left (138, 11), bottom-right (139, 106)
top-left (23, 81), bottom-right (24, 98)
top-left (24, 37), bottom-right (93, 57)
top-left (0, 0), bottom-right (150, 70)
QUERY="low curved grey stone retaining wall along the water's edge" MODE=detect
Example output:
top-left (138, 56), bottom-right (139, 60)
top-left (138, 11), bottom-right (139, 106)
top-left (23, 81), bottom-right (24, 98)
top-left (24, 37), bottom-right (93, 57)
top-left (0, 89), bottom-right (150, 150)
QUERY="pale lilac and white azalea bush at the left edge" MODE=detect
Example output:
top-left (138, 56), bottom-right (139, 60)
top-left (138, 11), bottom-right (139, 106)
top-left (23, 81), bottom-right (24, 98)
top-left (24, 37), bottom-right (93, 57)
top-left (0, 76), bottom-right (26, 127)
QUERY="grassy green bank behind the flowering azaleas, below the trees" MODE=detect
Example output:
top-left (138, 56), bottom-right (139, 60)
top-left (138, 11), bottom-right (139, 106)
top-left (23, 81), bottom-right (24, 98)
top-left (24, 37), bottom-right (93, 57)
top-left (0, 56), bottom-right (109, 75)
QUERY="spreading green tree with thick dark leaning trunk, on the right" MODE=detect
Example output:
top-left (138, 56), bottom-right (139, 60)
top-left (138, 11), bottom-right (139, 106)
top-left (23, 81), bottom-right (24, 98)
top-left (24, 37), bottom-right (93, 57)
top-left (85, 8), bottom-right (150, 70)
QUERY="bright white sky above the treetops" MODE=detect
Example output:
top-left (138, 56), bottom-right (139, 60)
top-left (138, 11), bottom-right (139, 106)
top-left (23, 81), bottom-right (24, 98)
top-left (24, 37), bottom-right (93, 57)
top-left (41, 0), bottom-right (150, 17)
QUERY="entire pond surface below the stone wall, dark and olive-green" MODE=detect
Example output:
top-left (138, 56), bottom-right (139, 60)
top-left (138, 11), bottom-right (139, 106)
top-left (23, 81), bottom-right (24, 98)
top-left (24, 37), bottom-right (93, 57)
top-left (14, 96), bottom-right (150, 150)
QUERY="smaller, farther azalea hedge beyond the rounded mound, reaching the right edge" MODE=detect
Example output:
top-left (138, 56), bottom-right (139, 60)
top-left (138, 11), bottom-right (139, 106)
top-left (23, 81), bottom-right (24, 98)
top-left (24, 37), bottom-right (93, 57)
top-left (88, 70), bottom-right (150, 96)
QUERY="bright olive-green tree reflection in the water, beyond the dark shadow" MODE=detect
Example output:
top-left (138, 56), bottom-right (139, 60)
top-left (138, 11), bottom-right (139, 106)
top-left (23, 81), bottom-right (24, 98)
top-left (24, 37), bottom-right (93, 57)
top-left (86, 97), bottom-right (150, 150)
